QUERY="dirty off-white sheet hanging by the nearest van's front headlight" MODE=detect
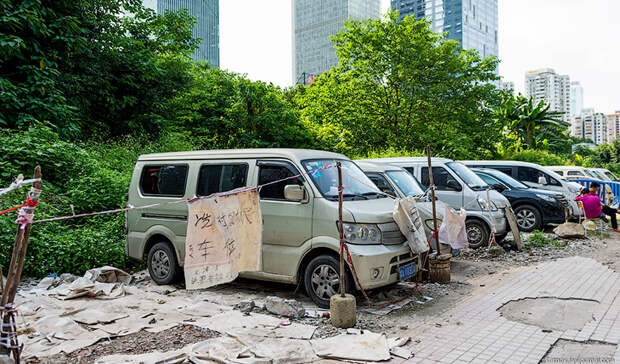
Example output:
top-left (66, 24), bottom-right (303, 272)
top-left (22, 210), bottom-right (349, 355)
top-left (393, 196), bottom-right (428, 254)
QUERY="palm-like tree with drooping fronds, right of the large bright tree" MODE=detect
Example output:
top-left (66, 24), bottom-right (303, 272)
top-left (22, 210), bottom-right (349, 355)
top-left (495, 93), bottom-right (570, 151)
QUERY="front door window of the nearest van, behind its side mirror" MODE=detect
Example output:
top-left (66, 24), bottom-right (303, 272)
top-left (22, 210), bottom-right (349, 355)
top-left (258, 161), bottom-right (304, 200)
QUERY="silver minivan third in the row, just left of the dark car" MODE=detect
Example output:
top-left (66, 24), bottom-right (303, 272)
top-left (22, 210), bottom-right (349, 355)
top-left (358, 157), bottom-right (510, 248)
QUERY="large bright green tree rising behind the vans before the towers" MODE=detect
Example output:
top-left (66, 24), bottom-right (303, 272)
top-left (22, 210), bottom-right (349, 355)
top-left (295, 12), bottom-right (498, 157)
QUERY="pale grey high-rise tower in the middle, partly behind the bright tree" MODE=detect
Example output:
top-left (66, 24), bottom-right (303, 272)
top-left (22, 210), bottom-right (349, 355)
top-left (293, 0), bottom-right (381, 84)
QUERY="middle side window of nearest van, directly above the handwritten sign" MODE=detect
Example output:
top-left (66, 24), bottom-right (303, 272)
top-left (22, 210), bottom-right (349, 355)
top-left (196, 164), bottom-right (248, 196)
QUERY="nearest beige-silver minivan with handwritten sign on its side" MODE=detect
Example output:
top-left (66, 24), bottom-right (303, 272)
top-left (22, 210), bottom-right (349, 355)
top-left (126, 149), bottom-right (419, 308)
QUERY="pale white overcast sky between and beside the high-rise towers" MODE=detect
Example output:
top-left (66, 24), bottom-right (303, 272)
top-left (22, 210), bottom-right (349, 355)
top-left (220, 0), bottom-right (620, 113)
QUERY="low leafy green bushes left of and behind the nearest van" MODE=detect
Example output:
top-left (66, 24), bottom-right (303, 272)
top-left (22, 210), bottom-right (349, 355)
top-left (0, 127), bottom-right (201, 276)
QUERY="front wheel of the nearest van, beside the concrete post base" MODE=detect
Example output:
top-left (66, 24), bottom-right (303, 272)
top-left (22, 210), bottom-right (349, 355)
top-left (304, 255), bottom-right (353, 309)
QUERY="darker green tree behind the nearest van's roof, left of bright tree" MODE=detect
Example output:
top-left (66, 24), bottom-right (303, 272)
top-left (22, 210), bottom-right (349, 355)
top-left (167, 63), bottom-right (314, 148)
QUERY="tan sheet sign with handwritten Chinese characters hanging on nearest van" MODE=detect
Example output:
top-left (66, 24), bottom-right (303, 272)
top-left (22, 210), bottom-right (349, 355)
top-left (184, 190), bottom-right (263, 289)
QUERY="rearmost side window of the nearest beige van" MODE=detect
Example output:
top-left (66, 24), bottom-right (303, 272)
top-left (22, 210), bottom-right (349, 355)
top-left (140, 164), bottom-right (188, 197)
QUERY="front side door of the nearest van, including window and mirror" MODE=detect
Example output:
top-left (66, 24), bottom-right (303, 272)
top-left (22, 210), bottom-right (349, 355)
top-left (256, 160), bottom-right (314, 276)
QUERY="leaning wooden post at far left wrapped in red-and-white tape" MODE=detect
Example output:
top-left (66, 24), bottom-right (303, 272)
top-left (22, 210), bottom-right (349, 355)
top-left (0, 166), bottom-right (43, 363)
